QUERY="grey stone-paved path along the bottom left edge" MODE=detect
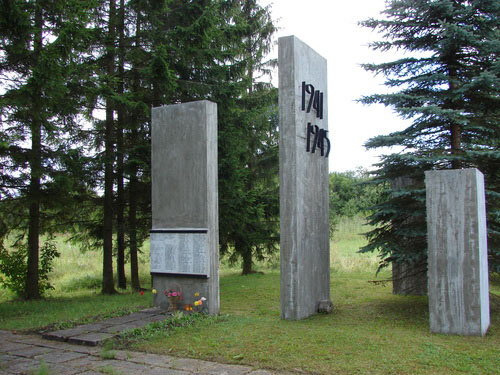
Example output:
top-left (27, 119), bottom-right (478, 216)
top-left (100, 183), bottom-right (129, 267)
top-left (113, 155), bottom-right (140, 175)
top-left (0, 331), bottom-right (284, 375)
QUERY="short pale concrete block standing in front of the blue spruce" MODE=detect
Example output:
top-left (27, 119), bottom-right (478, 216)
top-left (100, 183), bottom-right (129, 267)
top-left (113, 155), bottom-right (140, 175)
top-left (425, 169), bottom-right (490, 335)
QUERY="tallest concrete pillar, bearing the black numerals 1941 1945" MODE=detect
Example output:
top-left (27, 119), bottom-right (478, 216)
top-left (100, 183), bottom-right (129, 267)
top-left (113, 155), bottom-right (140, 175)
top-left (278, 36), bottom-right (330, 319)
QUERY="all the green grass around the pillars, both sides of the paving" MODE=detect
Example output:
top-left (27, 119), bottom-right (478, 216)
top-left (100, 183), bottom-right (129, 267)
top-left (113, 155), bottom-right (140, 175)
top-left (0, 216), bottom-right (500, 374)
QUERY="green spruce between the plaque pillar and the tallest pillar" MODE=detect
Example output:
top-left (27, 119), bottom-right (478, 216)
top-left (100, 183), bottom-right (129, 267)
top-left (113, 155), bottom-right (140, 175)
top-left (219, 0), bottom-right (279, 274)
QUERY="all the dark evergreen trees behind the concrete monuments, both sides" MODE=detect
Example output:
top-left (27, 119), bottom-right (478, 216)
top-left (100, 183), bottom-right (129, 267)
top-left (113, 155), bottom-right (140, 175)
top-left (0, 0), bottom-right (500, 299)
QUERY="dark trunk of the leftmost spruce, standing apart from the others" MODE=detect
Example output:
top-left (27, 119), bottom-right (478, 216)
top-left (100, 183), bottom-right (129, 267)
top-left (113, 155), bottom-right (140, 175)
top-left (24, 2), bottom-right (43, 300)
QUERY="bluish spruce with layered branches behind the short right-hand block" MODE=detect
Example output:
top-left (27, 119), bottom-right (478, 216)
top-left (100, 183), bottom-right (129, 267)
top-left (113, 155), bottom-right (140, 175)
top-left (362, 0), bottom-right (500, 282)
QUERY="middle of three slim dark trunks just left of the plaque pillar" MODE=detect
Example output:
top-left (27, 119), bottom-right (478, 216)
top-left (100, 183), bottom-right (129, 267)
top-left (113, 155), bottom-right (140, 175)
top-left (116, 0), bottom-right (127, 289)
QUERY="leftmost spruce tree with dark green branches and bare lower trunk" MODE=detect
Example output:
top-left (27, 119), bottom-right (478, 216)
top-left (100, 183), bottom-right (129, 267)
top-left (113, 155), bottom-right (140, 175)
top-left (0, 0), bottom-right (93, 299)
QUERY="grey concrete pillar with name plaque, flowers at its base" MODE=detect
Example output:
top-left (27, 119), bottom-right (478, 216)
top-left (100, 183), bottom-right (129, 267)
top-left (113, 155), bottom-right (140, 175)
top-left (151, 100), bottom-right (220, 314)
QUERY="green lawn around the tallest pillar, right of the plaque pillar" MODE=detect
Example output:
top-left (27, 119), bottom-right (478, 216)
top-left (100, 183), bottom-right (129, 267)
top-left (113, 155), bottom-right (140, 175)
top-left (122, 219), bottom-right (500, 375)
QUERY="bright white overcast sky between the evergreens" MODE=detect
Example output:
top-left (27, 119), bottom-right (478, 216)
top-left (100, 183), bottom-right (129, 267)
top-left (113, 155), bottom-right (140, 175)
top-left (259, 0), bottom-right (408, 172)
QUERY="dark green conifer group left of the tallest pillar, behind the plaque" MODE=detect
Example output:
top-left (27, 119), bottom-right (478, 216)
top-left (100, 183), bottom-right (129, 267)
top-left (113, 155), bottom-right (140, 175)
top-left (0, 0), bottom-right (277, 298)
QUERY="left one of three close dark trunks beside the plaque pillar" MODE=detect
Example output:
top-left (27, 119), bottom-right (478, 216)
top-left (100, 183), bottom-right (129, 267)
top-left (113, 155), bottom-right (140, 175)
top-left (102, 0), bottom-right (116, 294)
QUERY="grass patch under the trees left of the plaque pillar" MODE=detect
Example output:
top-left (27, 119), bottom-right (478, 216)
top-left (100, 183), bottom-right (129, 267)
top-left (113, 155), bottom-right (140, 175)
top-left (0, 236), bottom-right (152, 331)
